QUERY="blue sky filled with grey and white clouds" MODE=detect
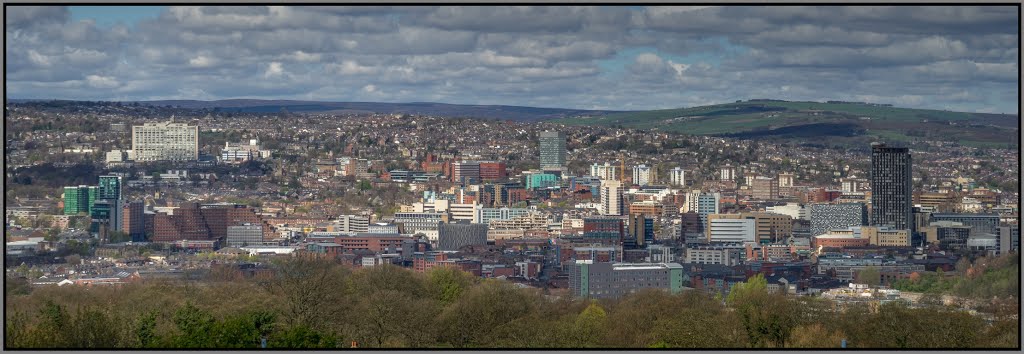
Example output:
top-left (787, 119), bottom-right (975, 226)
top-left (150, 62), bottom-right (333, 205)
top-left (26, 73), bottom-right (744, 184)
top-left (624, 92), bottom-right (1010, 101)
top-left (5, 5), bottom-right (1020, 114)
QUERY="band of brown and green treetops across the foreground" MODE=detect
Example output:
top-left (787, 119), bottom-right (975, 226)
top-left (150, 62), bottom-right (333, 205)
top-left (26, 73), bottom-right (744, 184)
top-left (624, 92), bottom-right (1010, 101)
top-left (4, 258), bottom-right (1019, 348)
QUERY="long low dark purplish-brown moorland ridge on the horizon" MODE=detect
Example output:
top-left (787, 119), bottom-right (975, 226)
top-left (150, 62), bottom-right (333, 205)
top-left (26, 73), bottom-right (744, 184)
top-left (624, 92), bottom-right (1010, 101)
top-left (130, 99), bottom-right (624, 122)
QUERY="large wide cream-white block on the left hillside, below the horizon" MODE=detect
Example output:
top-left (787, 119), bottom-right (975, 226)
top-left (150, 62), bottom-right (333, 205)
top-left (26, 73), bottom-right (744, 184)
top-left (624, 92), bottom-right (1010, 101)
top-left (131, 121), bottom-right (199, 162)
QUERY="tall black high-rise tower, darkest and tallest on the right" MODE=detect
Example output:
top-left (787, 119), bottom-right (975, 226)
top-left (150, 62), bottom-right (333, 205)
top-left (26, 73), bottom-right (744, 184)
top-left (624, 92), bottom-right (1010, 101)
top-left (871, 143), bottom-right (913, 230)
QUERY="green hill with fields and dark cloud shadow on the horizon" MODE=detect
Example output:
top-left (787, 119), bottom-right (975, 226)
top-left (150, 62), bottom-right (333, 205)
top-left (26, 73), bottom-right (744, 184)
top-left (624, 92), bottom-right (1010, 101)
top-left (552, 99), bottom-right (1020, 147)
